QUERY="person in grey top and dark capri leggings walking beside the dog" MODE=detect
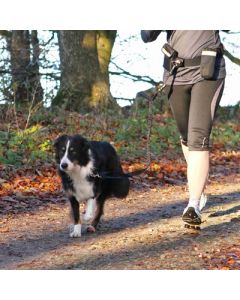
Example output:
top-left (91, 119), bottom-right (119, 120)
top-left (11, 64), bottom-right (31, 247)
top-left (141, 30), bottom-right (226, 225)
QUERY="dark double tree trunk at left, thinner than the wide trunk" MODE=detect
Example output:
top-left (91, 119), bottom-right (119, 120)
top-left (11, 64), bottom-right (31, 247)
top-left (8, 30), bottom-right (43, 105)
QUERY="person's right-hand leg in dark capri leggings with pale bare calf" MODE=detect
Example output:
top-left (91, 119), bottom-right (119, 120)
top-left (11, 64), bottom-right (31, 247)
top-left (184, 80), bottom-right (224, 220)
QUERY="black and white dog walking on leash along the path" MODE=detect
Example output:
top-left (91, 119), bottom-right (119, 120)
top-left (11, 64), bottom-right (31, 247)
top-left (54, 135), bottom-right (130, 237)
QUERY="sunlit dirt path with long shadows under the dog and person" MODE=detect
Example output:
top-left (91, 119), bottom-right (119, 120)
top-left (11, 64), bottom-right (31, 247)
top-left (0, 175), bottom-right (240, 269)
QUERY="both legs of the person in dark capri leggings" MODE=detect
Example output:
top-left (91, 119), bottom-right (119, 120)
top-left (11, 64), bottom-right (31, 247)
top-left (168, 80), bottom-right (224, 222)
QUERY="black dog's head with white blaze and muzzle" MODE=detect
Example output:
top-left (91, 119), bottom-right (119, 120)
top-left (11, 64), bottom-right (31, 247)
top-left (54, 135), bottom-right (91, 173)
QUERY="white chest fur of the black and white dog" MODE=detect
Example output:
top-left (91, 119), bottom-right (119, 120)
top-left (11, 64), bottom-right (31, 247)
top-left (69, 161), bottom-right (94, 202)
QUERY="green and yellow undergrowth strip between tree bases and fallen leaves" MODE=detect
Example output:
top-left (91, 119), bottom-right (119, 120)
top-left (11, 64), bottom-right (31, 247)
top-left (0, 104), bottom-right (240, 166)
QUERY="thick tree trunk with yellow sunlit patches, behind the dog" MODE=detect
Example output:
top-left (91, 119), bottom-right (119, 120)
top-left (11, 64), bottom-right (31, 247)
top-left (52, 30), bottom-right (116, 111)
